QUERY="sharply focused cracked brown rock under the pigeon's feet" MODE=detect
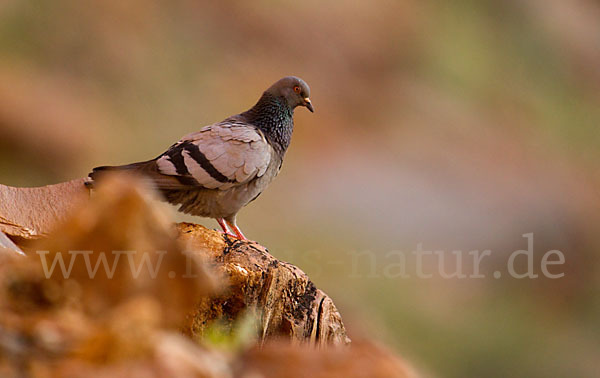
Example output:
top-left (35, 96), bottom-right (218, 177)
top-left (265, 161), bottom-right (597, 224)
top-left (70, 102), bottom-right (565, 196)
top-left (177, 223), bottom-right (350, 346)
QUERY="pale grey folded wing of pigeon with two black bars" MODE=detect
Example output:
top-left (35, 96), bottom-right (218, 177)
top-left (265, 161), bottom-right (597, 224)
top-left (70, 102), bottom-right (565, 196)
top-left (156, 122), bottom-right (272, 190)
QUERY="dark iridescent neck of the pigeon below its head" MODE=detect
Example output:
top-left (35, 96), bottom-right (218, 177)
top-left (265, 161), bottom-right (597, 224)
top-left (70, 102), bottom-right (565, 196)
top-left (242, 92), bottom-right (294, 153)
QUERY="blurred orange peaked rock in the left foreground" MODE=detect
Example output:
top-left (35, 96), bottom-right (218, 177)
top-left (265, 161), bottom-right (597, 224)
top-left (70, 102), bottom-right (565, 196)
top-left (0, 177), bottom-right (218, 377)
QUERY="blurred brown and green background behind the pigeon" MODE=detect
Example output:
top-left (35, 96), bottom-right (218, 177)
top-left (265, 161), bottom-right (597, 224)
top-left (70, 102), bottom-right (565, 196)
top-left (0, 0), bottom-right (600, 377)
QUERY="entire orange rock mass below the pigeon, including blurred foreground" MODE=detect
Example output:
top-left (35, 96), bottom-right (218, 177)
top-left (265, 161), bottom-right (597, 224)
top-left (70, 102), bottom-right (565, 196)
top-left (0, 176), bottom-right (412, 378)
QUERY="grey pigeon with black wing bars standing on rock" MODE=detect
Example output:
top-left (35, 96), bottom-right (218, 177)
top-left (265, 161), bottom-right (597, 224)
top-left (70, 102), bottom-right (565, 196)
top-left (86, 76), bottom-right (314, 240)
